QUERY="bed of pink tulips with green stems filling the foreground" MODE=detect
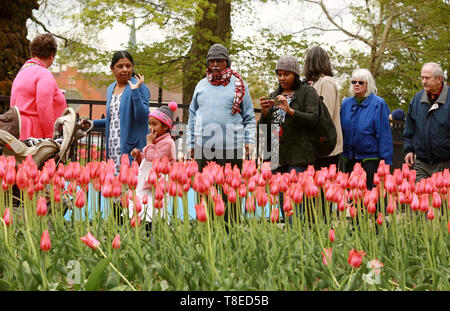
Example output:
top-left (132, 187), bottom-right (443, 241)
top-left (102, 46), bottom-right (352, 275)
top-left (0, 156), bottom-right (450, 291)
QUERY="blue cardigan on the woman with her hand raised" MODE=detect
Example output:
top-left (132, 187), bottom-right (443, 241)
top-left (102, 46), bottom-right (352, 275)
top-left (94, 77), bottom-right (150, 163)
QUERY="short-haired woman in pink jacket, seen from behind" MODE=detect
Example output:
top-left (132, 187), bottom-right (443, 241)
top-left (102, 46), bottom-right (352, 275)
top-left (10, 33), bottom-right (67, 140)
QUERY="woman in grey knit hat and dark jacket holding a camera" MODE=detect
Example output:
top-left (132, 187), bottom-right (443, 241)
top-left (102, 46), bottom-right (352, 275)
top-left (259, 55), bottom-right (320, 223)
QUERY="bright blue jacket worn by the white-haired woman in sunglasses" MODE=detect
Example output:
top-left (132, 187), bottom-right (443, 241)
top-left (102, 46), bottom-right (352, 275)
top-left (341, 93), bottom-right (394, 164)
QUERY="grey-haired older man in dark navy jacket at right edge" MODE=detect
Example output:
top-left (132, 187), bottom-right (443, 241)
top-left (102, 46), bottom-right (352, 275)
top-left (403, 63), bottom-right (450, 181)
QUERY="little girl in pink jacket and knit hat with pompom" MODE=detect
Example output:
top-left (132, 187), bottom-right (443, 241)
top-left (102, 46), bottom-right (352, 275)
top-left (129, 102), bottom-right (177, 227)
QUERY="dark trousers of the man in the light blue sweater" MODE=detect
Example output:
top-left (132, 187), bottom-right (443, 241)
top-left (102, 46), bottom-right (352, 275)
top-left (195, 149), bottom-right (243, 227)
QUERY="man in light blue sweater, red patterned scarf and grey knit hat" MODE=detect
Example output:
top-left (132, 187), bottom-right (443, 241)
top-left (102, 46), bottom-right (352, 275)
top-left (186, 44), bottom-right (256, 169)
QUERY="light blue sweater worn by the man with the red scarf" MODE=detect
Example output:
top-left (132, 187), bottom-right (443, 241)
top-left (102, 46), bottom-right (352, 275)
top-left (186, 76), bottom-right (256, 149)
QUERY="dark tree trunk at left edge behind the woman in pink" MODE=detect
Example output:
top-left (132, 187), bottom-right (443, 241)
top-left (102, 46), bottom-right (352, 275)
top-left (0, 0), bottom-right (39, 113)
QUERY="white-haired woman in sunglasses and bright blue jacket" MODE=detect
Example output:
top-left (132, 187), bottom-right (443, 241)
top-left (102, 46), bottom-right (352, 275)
top-left (341, 69), bottom-right (393, 189)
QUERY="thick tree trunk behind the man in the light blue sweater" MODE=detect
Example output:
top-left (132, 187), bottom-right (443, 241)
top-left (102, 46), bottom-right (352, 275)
top-left (183, 0), bottom-right (231, 123)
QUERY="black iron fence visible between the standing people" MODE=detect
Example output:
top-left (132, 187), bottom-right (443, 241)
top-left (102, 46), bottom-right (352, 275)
top-left (0, 96), bottom-right (404, 169)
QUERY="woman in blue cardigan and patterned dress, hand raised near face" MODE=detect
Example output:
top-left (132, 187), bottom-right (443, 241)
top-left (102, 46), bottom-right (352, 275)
top-left (94, 51), bottom-right (150, 175)
